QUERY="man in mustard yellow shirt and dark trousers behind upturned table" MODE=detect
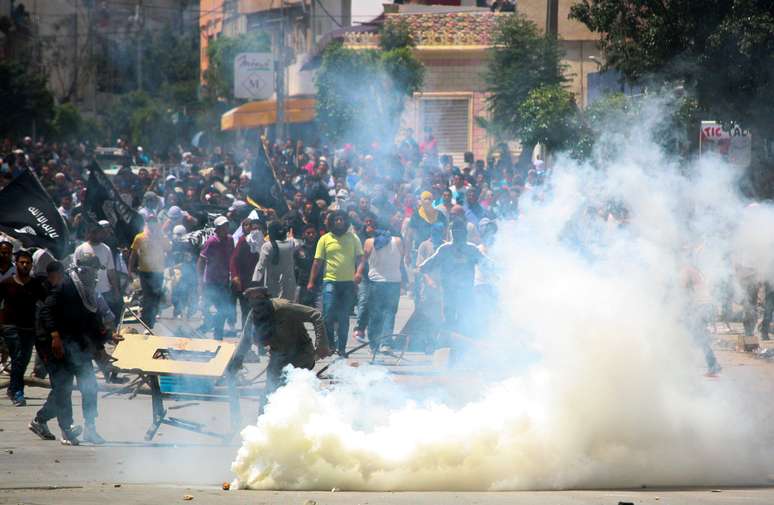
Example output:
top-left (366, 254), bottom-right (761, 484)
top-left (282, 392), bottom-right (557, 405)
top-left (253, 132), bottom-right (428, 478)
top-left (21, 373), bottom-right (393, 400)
top-left (129, 214), bottom-right (170, 328)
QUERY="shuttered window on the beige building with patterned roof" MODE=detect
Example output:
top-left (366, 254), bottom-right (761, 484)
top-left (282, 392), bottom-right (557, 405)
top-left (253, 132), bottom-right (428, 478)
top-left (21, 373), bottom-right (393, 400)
top-left (419, 97), bottom-right (471, 160)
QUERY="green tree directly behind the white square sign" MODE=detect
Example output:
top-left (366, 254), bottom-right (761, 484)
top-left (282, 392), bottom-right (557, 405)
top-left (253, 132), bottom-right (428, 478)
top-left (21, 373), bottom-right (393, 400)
top-left (204, 32), bottom-right (271, 100)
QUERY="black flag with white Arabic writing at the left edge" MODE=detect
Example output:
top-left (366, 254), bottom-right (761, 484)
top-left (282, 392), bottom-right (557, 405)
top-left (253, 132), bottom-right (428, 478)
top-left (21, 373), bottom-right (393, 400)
top-left (0, 170), bottom-right (70, 258)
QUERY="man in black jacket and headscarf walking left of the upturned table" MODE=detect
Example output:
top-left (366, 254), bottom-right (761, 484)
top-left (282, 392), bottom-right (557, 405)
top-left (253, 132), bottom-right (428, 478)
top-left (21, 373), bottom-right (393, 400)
top-left (40, 254), bottom-right (109, 445)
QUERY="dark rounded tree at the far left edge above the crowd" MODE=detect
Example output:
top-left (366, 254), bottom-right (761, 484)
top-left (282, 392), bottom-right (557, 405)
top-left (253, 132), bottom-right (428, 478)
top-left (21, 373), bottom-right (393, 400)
top-left (0, 61), bottom-right (54, 137)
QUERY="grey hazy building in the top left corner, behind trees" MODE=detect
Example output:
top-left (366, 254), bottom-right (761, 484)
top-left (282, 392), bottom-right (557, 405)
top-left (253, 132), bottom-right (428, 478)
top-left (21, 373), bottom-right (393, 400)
top-left (0, 0), bottom-right (199, 113)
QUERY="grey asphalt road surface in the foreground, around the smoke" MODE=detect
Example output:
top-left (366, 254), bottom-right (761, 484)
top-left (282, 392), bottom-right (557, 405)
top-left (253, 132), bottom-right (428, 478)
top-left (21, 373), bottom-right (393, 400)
top-left (0, 300), bottom-right (774, 505)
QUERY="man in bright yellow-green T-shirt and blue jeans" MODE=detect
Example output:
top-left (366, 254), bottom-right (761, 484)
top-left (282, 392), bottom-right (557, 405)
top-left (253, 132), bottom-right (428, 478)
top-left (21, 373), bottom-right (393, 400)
top-left (306, 211), bottom-right (363, 356)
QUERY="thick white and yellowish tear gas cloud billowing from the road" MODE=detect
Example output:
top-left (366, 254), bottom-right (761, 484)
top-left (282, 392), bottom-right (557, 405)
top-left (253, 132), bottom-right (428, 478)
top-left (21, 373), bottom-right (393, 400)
top-left (232, 100), bottom-right (774, 490)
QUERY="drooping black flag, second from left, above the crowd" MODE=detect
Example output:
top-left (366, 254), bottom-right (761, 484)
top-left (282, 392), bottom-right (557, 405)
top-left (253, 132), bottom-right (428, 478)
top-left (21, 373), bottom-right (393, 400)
top-left (83, 162), bottom-right (144, 246)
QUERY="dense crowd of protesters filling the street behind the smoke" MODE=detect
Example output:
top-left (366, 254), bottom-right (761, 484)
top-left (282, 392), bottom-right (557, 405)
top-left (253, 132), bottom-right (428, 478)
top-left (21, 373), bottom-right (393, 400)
top-left (0, 130), bottom-right (744, 444)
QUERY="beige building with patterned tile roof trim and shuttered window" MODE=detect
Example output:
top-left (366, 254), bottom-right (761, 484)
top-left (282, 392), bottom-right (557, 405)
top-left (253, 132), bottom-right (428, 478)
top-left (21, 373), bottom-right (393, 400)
top-left (343, 0), bottom-right (600, 162)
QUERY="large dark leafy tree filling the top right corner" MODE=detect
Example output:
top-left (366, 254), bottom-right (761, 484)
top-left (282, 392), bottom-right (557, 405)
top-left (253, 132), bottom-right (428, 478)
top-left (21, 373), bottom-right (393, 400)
top-left (570, 0), bottom-right (774, 134)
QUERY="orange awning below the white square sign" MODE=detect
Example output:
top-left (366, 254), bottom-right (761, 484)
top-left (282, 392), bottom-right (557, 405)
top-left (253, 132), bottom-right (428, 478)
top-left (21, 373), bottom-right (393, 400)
top-left (220, 98), bottom-right (317, 131)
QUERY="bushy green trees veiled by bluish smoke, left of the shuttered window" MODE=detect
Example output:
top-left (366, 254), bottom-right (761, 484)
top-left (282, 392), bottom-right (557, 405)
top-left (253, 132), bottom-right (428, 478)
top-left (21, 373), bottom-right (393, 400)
top-left (315, 39), bottom-right (424, 143)
